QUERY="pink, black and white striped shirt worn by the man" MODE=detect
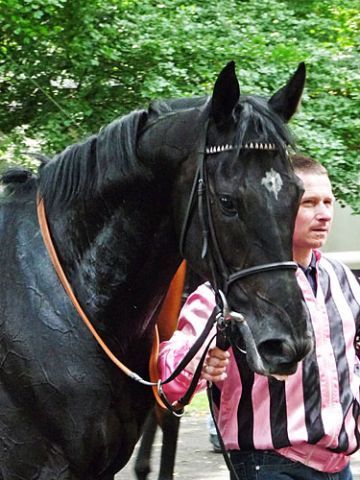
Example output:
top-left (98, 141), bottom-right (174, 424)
top-left (159, 251), bottom-right (360, 472)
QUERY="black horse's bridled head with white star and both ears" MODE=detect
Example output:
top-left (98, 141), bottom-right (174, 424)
top-left (138, 62), bottom-right (312, 375)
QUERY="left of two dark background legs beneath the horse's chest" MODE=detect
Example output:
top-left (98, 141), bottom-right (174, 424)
top-left (134, 408), bottom-right (158, 480)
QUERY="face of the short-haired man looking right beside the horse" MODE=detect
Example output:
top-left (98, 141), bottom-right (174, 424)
top-left (293, 171), bottom-right (334, 252)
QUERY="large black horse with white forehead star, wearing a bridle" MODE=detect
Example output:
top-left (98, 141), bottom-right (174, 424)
top-left (0, 62), bottom-right (311, 480)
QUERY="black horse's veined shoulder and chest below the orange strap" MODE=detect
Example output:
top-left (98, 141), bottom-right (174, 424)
top-left (0, 214), bottom-right (152, 480)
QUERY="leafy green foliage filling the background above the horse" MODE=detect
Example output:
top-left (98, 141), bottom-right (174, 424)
top-left (0, 0), bottom-right (360, 212)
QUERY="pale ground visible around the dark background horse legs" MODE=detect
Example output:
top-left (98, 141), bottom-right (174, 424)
top-left (115, 413), bottom-right (360, 480)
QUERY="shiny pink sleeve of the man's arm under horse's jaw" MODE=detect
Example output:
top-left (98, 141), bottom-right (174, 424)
top-left (158, 283), bottom-right (216, 402)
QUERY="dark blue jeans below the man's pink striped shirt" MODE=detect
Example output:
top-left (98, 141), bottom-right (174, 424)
top-left (229, 450), bottom-right (353, 480)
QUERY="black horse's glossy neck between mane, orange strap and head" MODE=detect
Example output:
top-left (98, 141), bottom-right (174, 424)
top-left (49, 179), bottom-right (180, 337)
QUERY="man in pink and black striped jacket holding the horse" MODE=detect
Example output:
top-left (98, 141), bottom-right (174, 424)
top-left (159, 156), bottom-right (360, 480)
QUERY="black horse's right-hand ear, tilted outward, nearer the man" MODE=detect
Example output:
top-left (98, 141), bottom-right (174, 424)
top-left (269, 62), bottom-right (306, 122)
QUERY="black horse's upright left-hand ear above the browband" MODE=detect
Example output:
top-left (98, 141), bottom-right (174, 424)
top-left (211, 61), bottom-right (240, 123)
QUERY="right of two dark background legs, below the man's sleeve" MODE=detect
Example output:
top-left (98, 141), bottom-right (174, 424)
top-left (158, 410), bottom-right (180, 480)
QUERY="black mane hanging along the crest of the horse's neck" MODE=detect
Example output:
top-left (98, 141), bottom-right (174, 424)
top-left (39, 110), bottom-right (146, 208)
